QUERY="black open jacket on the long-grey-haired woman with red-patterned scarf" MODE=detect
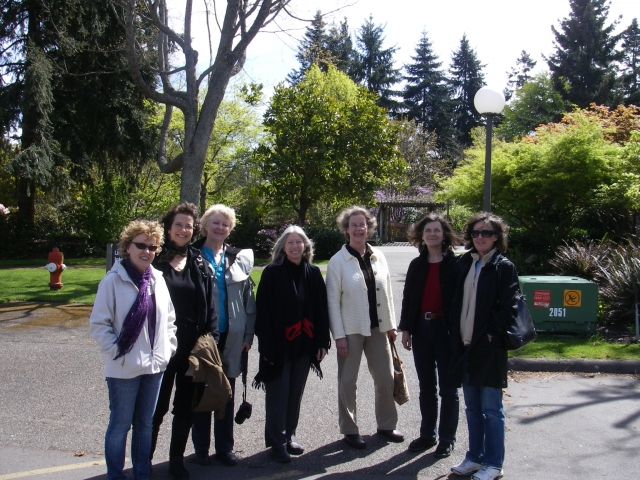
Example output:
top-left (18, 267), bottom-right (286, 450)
top-left (254, 256), bottom-right (331, 386)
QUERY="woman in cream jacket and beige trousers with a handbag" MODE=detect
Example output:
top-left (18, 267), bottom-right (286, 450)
top-left (327, 207), bottom-right (404, 448)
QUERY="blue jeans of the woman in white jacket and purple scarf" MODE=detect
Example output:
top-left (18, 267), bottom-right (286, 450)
top-left (104, 373), bottom-right (162, 480)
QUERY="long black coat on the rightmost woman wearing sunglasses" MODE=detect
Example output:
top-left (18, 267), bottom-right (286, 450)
top-left (450, 252), bottom-right (518, 388)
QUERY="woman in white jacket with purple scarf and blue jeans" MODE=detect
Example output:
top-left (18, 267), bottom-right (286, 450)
top-left (89, 220), bottom-right (177, 480)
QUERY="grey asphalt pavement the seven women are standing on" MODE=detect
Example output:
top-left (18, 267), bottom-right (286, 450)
top-left (0, 247), bottom-right (640, 480)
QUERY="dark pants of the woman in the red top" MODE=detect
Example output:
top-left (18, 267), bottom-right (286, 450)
top-left (411, 318), bottom-right (460, 443)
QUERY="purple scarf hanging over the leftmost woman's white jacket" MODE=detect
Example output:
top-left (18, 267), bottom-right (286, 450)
top-left (114, 258), bottom-right (151, 360)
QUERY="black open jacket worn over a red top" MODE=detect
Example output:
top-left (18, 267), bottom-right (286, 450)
top-left (398, 248), bottom-right (458, 333)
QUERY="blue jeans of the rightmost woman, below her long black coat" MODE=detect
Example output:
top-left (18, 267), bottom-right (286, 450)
top-left (462, 375), bottom-right (506, 468)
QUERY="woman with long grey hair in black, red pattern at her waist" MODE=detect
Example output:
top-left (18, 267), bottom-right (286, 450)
top-left (254, 225), bottom-right (331, 463)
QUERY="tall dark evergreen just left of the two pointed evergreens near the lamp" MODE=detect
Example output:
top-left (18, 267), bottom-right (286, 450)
top-left (351, 17), bottom-right (401, 111)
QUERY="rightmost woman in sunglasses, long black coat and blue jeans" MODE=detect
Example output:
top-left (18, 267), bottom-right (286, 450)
top-left (451, 212), bottom-right (518, 480)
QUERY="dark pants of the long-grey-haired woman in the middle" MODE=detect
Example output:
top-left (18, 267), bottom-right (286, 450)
top-left (264, 355), bottom-right (311, 449)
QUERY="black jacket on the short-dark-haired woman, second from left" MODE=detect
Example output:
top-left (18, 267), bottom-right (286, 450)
top-left (154, 246), bottom-right (219, 357)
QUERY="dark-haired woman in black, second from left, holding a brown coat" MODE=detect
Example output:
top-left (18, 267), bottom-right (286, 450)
top-left (151, 203), bottom-right (218, 480)
